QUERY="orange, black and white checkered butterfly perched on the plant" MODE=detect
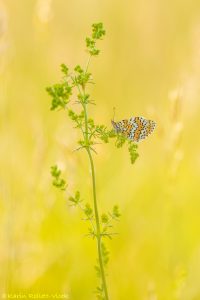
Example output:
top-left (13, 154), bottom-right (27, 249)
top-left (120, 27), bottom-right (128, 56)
top-left (111, 117), bottom-right (156, 142)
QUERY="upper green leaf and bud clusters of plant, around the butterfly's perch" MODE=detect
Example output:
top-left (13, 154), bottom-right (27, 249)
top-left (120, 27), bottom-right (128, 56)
top-left (47, 23), bottom-right (139, 163)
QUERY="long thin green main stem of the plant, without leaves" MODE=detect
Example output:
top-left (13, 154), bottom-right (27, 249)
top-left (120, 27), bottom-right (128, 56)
top-left (83, 101), bottom-right (109, 300)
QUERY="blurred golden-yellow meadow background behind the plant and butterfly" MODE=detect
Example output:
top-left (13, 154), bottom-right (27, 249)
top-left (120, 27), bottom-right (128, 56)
top-left (0, 0), bottom-right (200, 300)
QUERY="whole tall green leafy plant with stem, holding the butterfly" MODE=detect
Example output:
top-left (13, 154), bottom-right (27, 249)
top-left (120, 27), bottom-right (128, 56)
top-left (47, 23), bottom-right (138, 300)
